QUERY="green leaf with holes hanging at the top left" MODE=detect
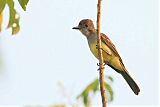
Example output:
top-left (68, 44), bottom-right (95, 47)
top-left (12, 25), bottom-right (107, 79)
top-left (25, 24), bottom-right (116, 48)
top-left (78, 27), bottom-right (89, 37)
top-left (7, 0), bottom-right (20, 35)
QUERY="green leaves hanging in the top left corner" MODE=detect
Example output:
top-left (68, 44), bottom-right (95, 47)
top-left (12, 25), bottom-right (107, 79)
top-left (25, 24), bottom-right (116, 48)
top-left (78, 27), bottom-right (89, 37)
top-left (0, 0), bottom-right (29, 35)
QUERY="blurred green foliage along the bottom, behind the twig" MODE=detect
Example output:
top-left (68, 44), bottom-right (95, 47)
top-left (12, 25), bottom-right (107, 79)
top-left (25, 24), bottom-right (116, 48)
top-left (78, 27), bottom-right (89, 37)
top-left (25, 76), bottom-right (114, 107)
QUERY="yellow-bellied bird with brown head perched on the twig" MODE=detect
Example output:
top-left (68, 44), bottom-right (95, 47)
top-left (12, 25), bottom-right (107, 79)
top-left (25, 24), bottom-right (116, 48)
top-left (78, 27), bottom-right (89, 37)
top-left (72, 19), bottom-right (140, 95)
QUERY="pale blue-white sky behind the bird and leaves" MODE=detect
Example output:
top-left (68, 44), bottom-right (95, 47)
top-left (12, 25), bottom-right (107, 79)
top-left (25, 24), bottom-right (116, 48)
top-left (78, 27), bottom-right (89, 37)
top-left (0, 0), bottom-right (159, 105)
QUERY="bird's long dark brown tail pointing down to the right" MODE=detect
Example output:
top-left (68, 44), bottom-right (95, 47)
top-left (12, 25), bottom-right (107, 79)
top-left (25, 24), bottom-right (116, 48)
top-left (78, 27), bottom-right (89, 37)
top-left (120, 70), bottom-right (140, 95)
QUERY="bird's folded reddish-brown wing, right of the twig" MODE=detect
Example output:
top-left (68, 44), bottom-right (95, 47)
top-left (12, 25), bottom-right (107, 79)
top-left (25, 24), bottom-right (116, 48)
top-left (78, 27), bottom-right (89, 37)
top-left (101, 33), bottom-right (124, 66)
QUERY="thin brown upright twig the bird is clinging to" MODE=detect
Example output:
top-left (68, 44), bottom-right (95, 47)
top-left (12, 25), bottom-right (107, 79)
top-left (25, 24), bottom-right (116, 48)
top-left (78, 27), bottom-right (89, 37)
top-left (97, 0), bottom-right (107, 107)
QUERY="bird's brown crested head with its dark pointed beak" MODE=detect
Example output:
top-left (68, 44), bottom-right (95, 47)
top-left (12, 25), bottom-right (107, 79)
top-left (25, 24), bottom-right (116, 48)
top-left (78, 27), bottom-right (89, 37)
top-left (73, 19), bottom-right (95, 37)
